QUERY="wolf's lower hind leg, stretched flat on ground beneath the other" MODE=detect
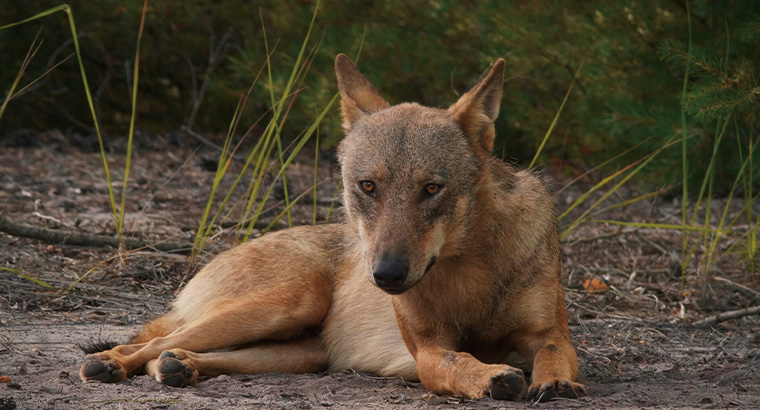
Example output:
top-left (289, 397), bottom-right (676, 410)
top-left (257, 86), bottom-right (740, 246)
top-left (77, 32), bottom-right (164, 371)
top-left (146, 336), bottom-right (328, 387)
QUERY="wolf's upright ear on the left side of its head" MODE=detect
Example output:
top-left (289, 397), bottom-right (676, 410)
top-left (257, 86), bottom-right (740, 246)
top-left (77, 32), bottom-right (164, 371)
top-left (335, 53), bottom-right (389, 132)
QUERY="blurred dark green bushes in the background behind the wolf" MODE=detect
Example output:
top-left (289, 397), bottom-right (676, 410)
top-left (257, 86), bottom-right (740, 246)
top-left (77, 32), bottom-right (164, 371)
top-left (0, 0), bottom-right (760, 187)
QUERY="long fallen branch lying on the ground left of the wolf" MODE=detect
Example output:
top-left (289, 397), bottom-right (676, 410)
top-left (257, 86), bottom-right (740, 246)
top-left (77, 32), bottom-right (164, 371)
top-left (0, 215), bottom-right (193, 253)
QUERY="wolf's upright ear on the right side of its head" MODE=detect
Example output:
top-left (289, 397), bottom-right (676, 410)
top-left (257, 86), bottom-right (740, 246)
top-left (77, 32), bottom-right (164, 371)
top-left (449, 58), bottom-right (504, 158)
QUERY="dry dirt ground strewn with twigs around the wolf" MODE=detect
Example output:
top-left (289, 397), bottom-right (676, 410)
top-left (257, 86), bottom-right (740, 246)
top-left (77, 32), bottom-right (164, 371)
top-left (0, 132), bottom-right (760, 410)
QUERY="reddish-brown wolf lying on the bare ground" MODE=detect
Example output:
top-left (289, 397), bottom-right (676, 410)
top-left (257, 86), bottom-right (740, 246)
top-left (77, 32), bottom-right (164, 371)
top-left (80, 54), bottom-right (586, 400)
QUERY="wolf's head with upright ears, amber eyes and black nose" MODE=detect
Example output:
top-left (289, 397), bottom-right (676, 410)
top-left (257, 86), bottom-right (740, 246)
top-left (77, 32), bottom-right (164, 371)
top-left (335, 54), bottom-right (504, 294)
